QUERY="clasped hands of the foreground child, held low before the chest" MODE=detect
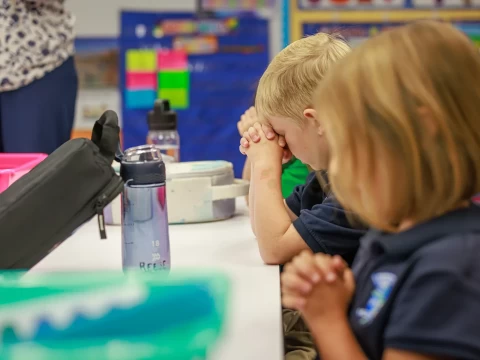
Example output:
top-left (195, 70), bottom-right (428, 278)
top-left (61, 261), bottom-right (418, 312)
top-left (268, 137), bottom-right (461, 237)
top-left (282, 250), bottom-right (355, 320)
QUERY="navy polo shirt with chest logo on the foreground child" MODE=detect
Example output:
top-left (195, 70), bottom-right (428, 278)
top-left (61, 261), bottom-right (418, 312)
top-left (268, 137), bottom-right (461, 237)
top-left (349, 204), bottom-right (480, 360)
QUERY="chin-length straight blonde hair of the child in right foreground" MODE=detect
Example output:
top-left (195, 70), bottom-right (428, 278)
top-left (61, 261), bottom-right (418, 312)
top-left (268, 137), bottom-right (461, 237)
top-left (314, 21), bottom-right (480, 231)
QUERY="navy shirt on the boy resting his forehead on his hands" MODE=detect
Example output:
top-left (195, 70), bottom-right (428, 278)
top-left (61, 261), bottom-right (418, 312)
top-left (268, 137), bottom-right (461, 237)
top-left (285, 172), bottom-right (366, 264)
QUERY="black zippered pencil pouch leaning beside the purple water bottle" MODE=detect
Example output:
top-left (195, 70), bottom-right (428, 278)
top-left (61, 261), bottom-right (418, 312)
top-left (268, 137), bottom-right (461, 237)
top-left (0, 111), bottom-right (123, 269)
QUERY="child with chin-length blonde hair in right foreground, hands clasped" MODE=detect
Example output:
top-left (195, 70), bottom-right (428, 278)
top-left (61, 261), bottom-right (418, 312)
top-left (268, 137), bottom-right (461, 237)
top-left (282, 21), bottom-right (480, 360)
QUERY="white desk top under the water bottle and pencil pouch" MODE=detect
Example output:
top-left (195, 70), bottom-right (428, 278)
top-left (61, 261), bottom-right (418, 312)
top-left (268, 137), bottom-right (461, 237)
top-left (32, 199), bottom-right (283, 360)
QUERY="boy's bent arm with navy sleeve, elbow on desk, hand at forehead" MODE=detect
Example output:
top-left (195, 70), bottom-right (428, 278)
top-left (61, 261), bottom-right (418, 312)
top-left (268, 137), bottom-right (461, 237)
top-left (240, 126), bottom-right (365, 264)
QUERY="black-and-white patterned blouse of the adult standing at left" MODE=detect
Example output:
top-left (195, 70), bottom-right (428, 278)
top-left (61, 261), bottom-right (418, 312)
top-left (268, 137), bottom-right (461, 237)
top-left (0, 0), bottom-right (75, 92)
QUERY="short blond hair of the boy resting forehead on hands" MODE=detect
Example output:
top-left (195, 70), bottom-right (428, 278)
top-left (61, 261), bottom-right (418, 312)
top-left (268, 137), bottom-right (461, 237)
top-left (255, 33), bottom-right (350, 122)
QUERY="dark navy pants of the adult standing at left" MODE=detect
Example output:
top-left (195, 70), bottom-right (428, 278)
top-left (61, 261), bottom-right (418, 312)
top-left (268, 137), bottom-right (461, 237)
top-left (0, 57), bottom-right (78, 154)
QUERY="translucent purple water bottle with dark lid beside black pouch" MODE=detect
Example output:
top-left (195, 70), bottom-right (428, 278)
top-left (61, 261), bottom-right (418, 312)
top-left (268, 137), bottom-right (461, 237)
top-left (120, 145), bottom-right (170, 271)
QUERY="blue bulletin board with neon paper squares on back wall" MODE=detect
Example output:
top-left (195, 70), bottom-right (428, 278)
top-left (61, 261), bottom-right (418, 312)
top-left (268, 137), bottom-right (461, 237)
top-left (119, 12), bottom-right (269, 176)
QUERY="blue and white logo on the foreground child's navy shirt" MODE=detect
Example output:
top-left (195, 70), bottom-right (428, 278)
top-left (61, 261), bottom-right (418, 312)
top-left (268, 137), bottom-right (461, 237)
top-left (355, 272), bottom-right (397, 325)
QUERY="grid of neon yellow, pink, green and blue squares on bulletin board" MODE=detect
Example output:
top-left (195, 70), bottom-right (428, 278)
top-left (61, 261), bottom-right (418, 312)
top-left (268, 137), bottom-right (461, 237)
top-left (124, 49), bottom-right (190, 109)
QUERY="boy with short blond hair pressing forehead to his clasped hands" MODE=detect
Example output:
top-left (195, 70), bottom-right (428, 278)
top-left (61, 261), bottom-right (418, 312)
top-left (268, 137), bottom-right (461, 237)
top-left (240, 33), bottom-right (364, 264)
